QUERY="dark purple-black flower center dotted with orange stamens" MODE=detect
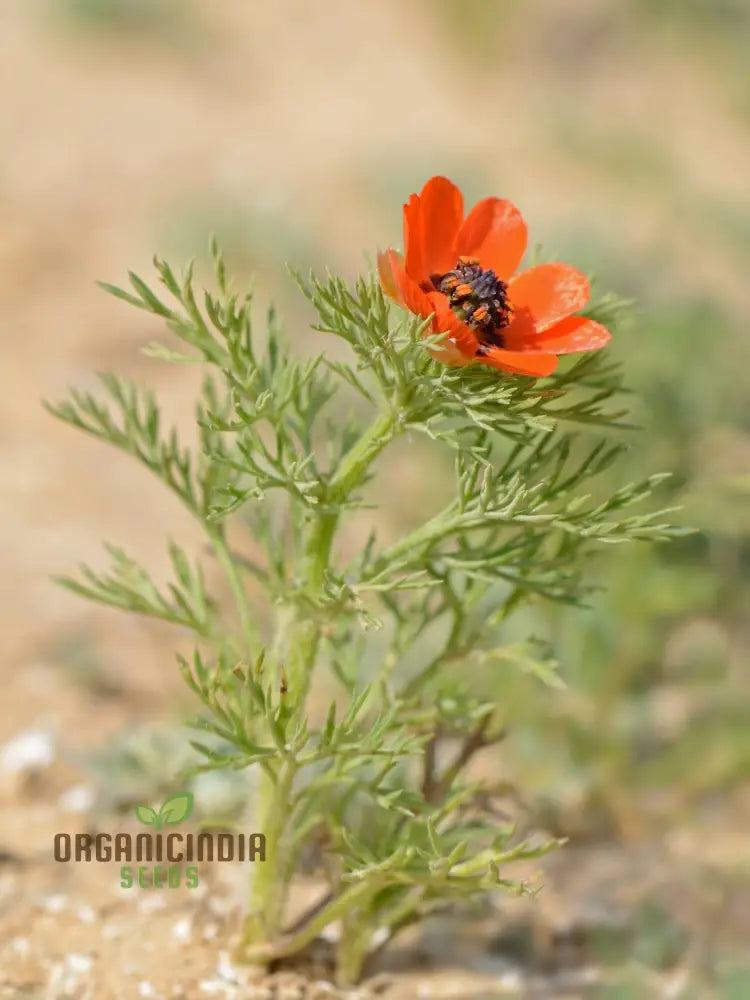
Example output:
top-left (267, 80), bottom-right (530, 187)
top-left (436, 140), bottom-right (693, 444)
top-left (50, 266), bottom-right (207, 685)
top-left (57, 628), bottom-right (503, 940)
top-left (430, 257), bottom-right (511, 354)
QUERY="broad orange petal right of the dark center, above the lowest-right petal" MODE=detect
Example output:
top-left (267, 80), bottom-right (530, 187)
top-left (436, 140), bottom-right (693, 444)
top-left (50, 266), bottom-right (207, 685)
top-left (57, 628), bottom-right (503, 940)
top-left (508, 264), bottom-right (589, 336)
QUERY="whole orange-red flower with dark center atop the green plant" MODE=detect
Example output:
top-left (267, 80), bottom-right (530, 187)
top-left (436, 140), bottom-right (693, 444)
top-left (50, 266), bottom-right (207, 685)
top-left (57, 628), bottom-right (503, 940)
top-left (378, 177), bottom-right (610, 376)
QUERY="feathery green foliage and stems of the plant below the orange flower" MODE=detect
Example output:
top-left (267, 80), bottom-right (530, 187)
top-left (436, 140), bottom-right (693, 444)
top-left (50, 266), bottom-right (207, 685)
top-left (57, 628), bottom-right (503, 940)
top-left (49, 244), bottom-right (675, 982)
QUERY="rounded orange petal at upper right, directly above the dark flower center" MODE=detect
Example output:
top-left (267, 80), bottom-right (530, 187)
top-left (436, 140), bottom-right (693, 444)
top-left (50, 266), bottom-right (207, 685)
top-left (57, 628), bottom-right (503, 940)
top-left (455, 198), bottom-right (528, 281)
